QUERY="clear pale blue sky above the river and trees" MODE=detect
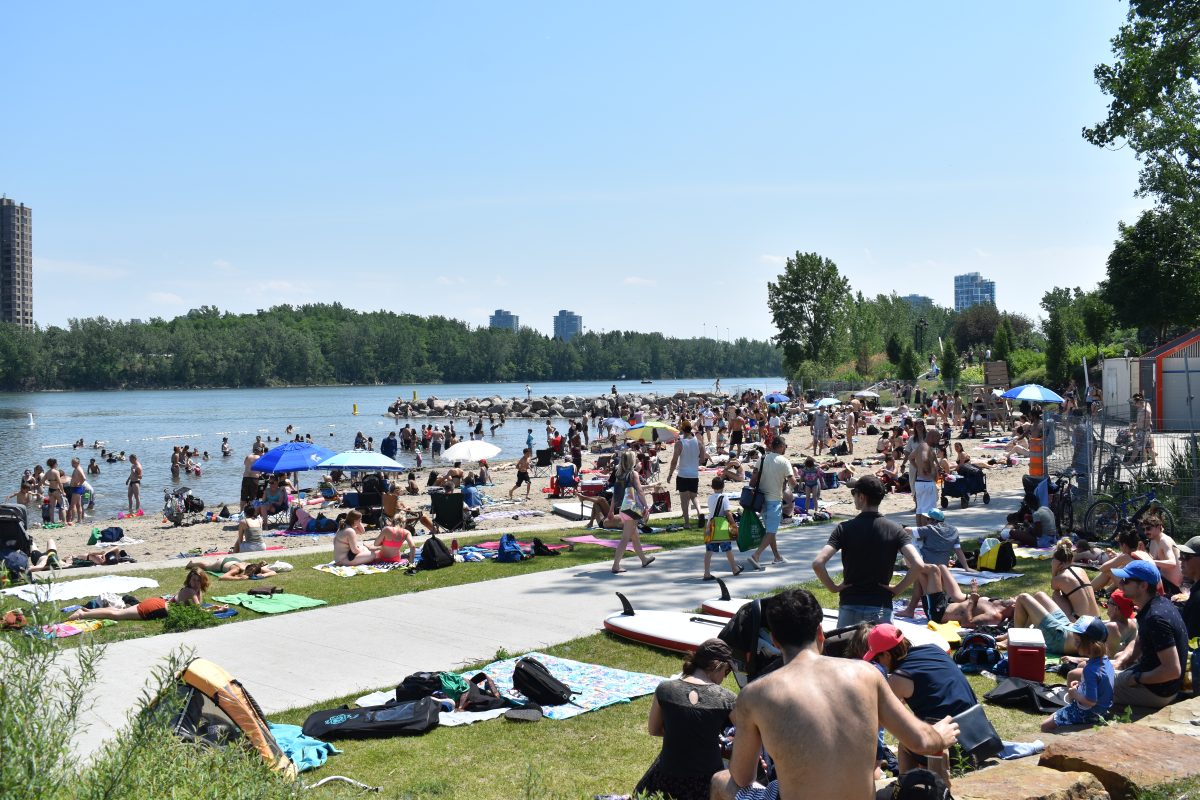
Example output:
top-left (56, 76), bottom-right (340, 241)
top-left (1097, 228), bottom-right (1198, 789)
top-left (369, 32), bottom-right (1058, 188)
top-left (0, 0), bottom-right (1145, 337)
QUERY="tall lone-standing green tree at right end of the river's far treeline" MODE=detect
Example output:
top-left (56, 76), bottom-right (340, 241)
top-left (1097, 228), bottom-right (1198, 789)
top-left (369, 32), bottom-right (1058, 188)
top-left (767, 251), bottom-right (850, 372)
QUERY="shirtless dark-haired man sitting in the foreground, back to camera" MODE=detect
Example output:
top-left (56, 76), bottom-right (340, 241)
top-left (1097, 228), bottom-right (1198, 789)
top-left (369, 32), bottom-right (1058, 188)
top-left (710, 589), bottom-right (959, 800)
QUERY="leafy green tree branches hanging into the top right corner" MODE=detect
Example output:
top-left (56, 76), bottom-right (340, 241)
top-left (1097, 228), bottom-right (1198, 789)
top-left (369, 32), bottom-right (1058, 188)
top-left (1084, 0), bottom-right (1200, 219)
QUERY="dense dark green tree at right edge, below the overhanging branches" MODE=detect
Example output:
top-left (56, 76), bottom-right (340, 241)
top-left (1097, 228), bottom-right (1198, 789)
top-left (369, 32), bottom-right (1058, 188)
top-left (1100, 210), bottom-right (1200, 342)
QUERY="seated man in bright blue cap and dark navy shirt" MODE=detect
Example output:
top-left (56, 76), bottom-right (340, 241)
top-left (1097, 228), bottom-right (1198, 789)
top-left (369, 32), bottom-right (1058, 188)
top-left (1112, 561), bottom-right (1188, 709)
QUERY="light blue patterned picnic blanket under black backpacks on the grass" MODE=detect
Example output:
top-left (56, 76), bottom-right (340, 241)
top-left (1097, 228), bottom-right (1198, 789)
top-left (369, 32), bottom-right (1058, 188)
top-left (358, 652), bottom-right (664, 726)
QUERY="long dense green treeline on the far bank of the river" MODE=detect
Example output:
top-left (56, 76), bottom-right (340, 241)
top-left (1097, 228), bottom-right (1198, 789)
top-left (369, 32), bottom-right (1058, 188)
top-left (0, 303), bottom-right (782, 391)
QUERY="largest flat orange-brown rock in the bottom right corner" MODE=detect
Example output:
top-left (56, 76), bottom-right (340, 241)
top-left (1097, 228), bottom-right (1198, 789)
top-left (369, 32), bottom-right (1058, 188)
top-left (1038, 724), bottom-right (1200, 800)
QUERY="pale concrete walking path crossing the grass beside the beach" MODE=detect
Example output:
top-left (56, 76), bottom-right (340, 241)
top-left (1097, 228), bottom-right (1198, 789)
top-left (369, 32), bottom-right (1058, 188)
top-left (65, 495), bottom-right (1018, 754)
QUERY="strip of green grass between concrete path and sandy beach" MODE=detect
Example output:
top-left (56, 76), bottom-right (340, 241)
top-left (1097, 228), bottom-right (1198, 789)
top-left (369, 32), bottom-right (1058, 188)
top-left (0, 517), bottom-right (832, 646)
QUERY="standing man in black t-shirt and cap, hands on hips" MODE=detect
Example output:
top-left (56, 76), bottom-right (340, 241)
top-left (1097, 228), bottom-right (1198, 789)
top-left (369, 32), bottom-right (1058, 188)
top-left (812, 475), bottom-right (925, 627)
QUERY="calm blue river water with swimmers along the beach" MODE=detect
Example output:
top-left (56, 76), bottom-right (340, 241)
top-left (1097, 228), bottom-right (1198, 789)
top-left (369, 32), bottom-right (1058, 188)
top-left (0, 378), bottom-right (785, 517)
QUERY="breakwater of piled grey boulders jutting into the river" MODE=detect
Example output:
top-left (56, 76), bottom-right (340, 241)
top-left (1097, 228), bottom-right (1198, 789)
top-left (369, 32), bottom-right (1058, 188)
top-left (388, 391), bottom-right (727, 420)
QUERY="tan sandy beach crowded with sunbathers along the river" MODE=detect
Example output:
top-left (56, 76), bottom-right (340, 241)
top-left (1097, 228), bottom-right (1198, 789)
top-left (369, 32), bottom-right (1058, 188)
top-left (21, 412), bottom-right (1027, 573)
